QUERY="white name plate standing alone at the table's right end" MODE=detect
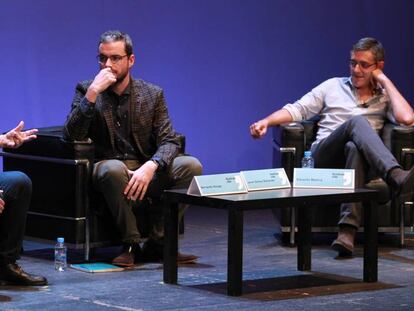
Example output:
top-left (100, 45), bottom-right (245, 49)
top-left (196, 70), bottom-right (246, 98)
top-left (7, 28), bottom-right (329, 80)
top-left (293, 168), bottom-right (355, 189)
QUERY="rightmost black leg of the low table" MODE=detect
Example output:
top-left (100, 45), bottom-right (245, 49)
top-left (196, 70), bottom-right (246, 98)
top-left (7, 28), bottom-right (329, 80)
top-left (364, 201), bottom-right (378, 282)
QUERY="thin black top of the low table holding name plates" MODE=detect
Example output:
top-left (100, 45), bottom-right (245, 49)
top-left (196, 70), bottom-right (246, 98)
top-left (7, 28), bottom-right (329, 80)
top-left (164, 188), bottom-right (378, 210)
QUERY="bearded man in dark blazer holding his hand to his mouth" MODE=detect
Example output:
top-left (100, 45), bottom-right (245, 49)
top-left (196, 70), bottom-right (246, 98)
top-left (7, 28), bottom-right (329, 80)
top-left (64, 31), bottom-right (201, 267)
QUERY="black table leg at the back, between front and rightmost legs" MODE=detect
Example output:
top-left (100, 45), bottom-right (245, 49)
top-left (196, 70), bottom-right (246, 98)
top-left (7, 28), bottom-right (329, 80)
top-left (297, 205), bottom-right (312, 271)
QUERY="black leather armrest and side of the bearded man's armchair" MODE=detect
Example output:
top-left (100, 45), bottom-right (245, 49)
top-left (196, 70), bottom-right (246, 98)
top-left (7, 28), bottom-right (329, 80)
top-left (2, 127), bottom-right (94, 219)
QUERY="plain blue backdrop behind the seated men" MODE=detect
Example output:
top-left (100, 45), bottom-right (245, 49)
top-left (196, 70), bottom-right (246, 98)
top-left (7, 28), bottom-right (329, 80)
top-left (0, 0), bottom-right (414, 173)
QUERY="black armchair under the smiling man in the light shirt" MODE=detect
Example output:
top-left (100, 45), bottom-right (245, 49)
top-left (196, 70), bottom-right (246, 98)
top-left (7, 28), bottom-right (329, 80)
top-left (273, 120), bottom-right (414, 246)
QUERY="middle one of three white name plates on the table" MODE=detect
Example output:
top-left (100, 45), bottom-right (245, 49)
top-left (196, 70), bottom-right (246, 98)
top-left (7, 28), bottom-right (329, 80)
top-left (240, 168), bottom-right (290, 191)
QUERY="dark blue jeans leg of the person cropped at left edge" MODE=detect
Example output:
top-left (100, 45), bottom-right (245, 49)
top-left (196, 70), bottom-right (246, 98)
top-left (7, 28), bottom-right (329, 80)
top-left (0, 172), bottom-right (32, 265)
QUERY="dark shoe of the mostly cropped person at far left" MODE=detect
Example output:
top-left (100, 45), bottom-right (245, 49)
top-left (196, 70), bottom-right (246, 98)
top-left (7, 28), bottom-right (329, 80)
top-left (0, 263), bottom-right (47, 286)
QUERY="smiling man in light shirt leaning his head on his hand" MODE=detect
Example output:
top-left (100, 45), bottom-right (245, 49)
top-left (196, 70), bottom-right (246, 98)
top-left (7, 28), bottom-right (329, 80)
top-left (250, 38), bottom-right (414, 256)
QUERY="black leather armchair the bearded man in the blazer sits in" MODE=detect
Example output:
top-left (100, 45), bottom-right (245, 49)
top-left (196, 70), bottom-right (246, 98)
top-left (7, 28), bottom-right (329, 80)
top-left (1, 126), bottom-right (185, 260)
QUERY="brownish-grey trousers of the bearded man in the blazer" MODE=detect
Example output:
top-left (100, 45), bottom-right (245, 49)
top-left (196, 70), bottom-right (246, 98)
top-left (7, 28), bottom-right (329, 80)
top-left (92, 155), bottom-right (202, 244)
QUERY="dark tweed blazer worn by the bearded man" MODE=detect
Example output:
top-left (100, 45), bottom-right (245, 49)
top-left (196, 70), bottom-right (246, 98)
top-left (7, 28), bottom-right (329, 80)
top-left (63, 78), bottom-right (181, 169)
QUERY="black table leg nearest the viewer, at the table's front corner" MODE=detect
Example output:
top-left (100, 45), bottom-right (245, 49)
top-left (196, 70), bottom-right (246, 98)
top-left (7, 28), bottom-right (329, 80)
top-left (227, 208), bottom-right (243, 296)
